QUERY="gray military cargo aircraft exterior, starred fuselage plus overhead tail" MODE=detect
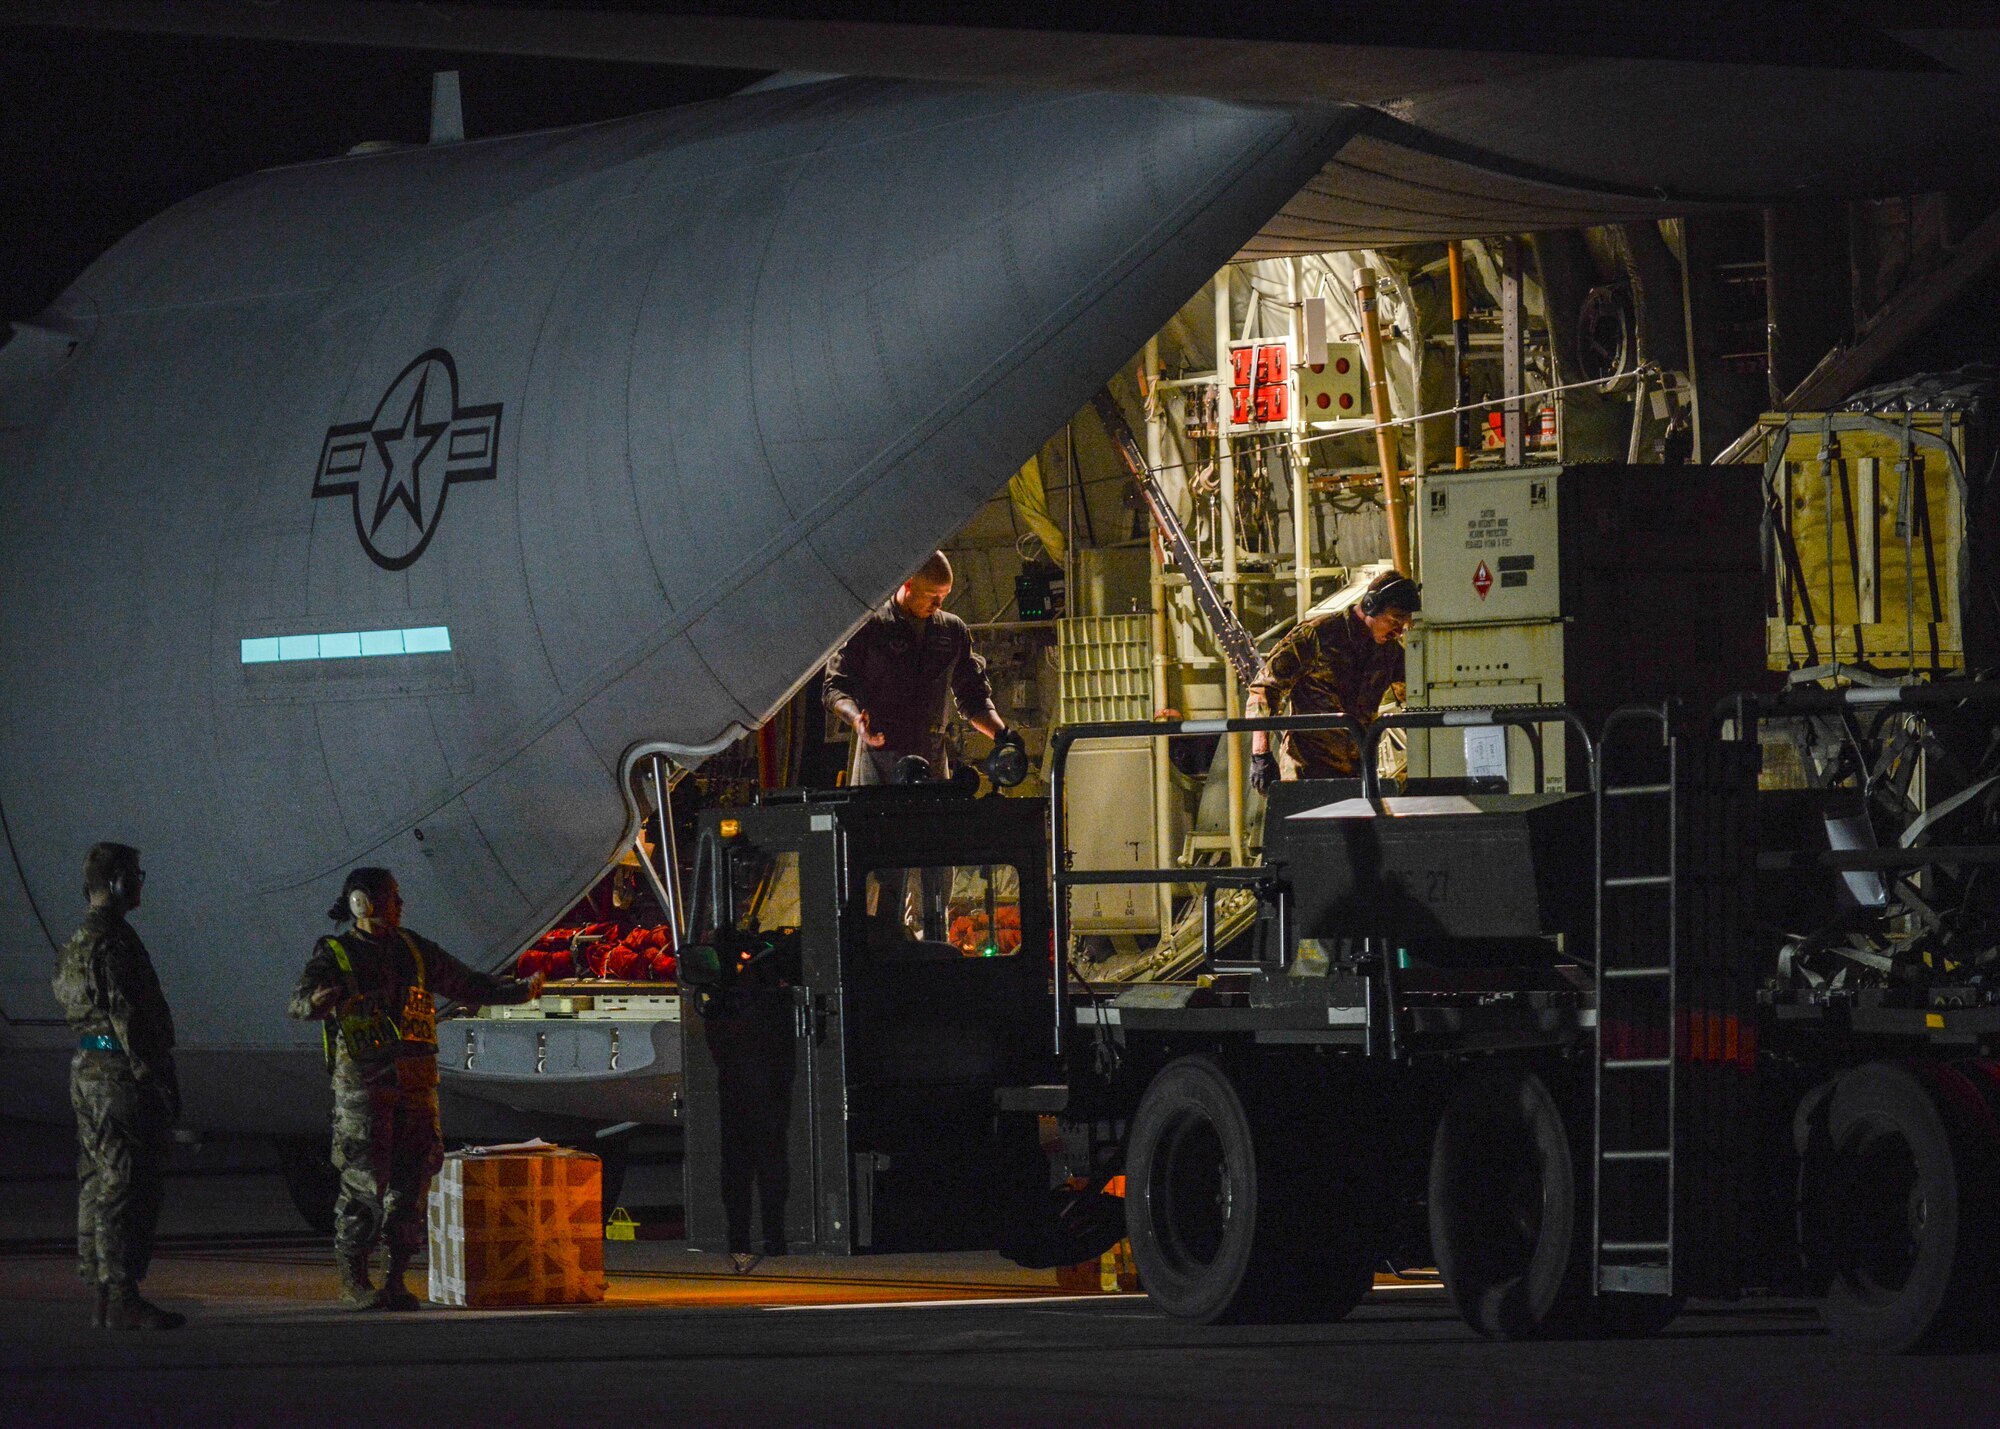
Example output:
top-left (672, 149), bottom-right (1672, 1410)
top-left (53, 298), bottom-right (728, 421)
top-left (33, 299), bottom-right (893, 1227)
top-left (0, 0), bottom-right (2000, 1160)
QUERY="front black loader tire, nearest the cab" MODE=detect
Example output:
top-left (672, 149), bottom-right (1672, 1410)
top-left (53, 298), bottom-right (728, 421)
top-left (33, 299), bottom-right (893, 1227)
top-left (1124, 1057), bottom-right (1378, 1325)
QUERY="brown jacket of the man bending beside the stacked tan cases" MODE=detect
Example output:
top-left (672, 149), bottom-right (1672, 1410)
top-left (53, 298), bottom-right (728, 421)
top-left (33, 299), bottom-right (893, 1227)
top-left (1250, 606), bottom-right (1404, 779)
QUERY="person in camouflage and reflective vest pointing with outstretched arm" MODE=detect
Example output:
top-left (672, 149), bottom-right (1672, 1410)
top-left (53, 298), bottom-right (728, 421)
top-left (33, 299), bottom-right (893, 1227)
top-left (290, 869), bottom-right (542, 1309)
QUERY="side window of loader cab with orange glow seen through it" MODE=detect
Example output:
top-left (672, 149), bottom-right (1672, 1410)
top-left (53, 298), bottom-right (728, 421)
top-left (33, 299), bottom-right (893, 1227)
top-left (862, 863), bottom-right (1020, 963)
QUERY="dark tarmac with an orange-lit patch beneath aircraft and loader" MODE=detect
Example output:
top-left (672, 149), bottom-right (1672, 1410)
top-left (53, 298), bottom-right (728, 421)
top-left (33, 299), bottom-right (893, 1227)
top-left (0, 1129), bottom-right (2000, 1429)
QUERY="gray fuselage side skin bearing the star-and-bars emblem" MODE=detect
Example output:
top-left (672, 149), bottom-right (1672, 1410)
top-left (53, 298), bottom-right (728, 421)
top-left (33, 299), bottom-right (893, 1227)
top-left (0, 80), bottom-right (1354, 1135)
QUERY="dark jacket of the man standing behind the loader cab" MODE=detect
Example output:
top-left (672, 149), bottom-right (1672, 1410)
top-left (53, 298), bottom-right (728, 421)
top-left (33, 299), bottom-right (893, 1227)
top-left (824, 600), bottom-right (1000, 773)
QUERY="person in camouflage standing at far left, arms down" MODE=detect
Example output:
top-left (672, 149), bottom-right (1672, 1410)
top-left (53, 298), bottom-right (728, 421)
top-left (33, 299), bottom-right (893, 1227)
top-left (54, 843), bottom-right (186, 1329)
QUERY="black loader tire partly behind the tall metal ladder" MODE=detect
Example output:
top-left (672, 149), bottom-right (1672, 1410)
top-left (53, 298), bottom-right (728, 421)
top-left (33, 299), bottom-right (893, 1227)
top-left (1430, 1067), bottom-right (1686, 1339)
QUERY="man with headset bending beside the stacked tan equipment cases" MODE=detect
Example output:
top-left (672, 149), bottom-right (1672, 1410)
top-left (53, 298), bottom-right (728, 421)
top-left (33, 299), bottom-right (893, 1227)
top-left (1244, 570), bottom-right (1420, 789)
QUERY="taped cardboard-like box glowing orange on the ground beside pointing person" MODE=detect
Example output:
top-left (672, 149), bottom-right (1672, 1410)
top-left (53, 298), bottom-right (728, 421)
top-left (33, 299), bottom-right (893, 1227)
top-left (430, 1149), bottom-right (604, 1309)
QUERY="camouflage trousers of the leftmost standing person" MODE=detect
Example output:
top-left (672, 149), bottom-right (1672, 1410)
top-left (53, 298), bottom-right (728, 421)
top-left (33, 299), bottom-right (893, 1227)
top-left (70, 1051), bottom-right (174, 1285)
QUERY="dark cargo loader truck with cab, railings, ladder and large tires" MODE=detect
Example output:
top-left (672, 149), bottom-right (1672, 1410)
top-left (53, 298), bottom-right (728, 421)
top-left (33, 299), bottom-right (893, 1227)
top-left (682, 680), bottom-right (2000, 1351)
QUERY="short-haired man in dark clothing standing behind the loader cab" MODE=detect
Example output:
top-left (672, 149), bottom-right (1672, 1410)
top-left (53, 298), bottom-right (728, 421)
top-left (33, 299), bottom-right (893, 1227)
top-left (824, 550), bottom-right (1022, 785)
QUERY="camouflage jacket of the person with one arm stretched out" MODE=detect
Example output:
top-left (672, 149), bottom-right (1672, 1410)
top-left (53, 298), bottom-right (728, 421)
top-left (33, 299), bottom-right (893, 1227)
top-left (286, 929), bottom-right (528, 1087)
